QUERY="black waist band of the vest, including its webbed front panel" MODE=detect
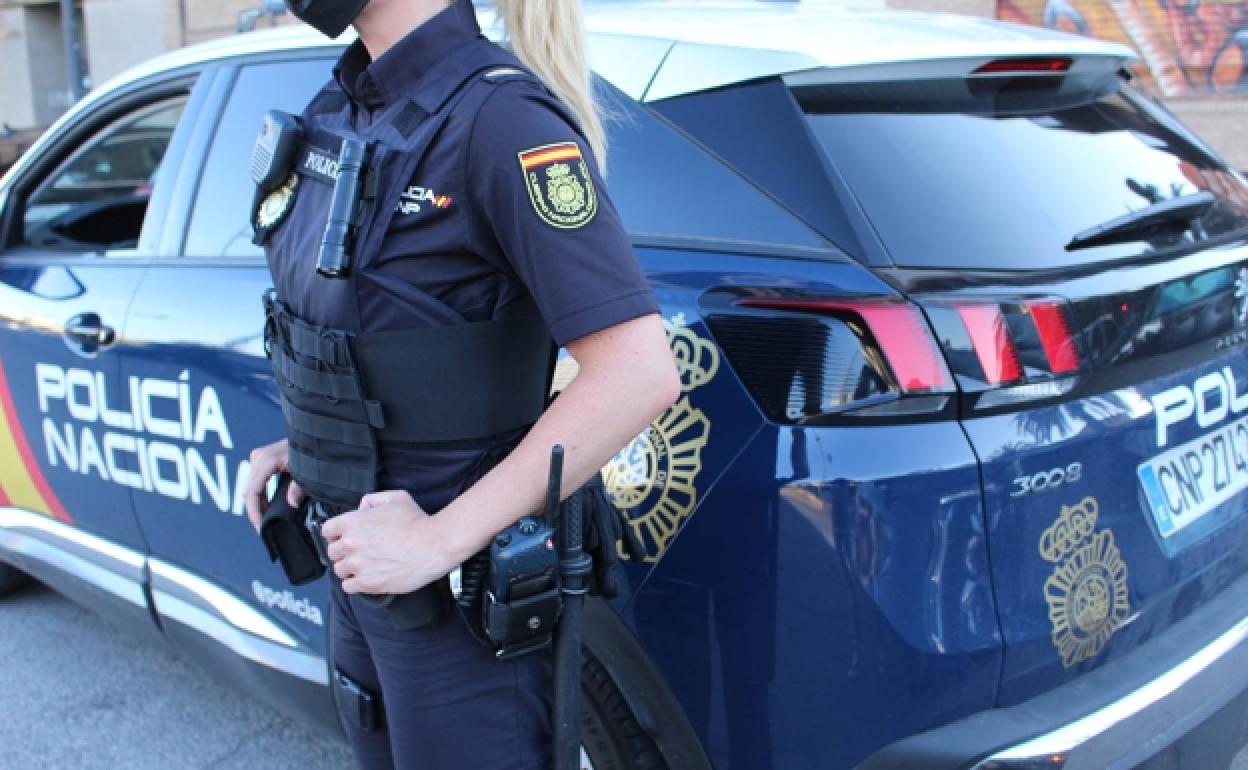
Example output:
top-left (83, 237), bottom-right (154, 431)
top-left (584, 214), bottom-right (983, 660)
top-left (265, 290), bottom-right (554, 504)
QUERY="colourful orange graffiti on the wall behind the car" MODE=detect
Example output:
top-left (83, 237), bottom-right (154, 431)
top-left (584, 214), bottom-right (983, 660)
top-left (997, 0), bottom-right (1248, 97)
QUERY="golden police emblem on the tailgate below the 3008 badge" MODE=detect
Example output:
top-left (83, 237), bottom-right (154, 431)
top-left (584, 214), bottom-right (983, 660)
top-left (1040, 497), bottom-right (1131, 668)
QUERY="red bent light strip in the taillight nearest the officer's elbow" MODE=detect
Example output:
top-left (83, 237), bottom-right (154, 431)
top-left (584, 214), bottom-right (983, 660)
top-left (738, 297), bottom-right (953, 392)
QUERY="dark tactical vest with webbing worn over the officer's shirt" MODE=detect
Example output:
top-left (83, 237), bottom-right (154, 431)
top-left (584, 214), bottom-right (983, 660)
top-left (257, 41), bottom-right (555, 509)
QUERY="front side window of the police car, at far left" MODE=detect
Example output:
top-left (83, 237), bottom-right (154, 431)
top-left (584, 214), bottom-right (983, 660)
top-left (22, 96), bottom-right (186, 252)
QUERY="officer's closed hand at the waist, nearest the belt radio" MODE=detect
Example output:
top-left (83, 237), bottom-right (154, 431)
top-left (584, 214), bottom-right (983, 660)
top-left (321, 490), bottom-right (463, 594)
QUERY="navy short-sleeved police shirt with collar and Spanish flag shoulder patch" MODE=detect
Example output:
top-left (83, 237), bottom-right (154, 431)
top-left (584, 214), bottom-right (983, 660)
top-left (312, 0), bottom-right (658, 344)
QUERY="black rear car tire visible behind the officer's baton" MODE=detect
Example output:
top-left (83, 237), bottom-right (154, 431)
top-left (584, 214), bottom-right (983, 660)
top-left (580, 653), bottom-right (668, 770)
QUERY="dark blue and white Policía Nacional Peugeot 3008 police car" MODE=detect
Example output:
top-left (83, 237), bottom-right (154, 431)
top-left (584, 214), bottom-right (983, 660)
top-left (0, 4), bottom-right (1248, 769)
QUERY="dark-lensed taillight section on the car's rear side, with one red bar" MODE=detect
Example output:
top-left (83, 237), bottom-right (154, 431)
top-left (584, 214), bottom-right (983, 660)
top-left (706, 295), bottom-right (956, 423)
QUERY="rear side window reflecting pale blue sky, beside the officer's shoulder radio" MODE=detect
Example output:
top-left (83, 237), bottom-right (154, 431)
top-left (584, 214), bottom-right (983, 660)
top-left (183, 59), bottom-right (333, 257)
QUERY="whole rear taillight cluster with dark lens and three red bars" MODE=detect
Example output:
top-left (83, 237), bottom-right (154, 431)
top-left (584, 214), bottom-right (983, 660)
top-left (703, 288), bottom-right (1085, 424)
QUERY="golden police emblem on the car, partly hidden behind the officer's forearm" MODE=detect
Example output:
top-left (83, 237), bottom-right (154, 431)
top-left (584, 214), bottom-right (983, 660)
top-left (603, 314), bottom-right (719, 562)
